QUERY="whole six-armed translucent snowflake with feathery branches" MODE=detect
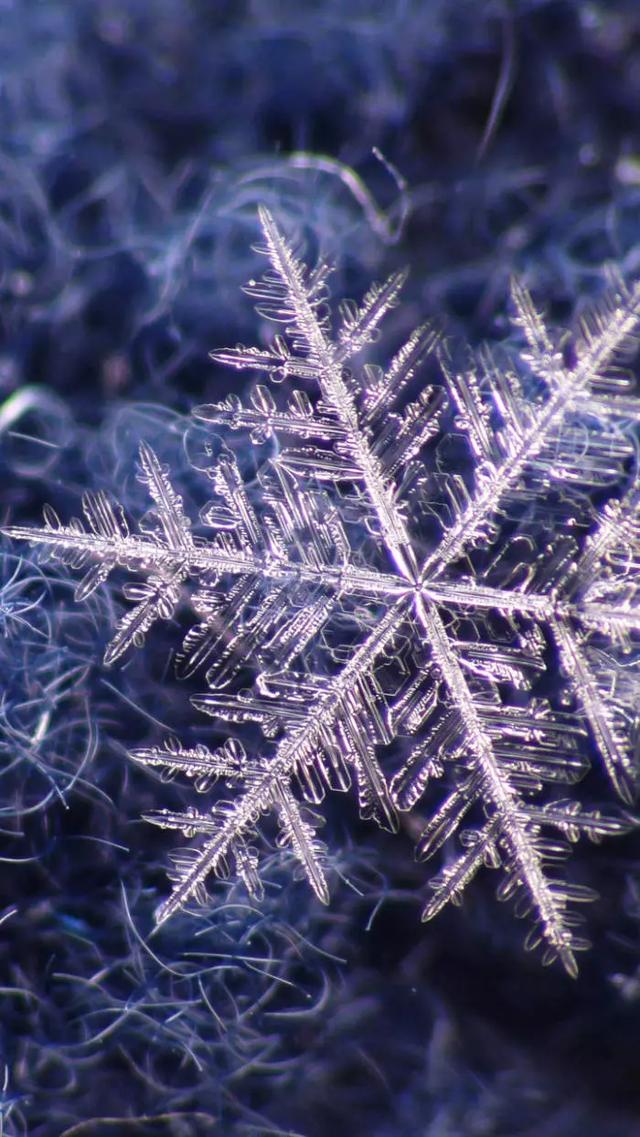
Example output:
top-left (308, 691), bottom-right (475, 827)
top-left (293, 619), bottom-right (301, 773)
top-left (7, 209), bottom-right (640, 974)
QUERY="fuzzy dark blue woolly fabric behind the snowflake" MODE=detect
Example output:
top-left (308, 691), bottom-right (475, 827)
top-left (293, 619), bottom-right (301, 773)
top-left (0, 0), bottom-right (640, 1137)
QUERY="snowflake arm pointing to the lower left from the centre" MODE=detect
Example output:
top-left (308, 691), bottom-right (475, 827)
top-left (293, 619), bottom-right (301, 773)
top-left (131, 601), bottom-right (401, 923)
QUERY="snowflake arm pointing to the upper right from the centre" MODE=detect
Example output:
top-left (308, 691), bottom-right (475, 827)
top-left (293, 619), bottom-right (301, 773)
top-left (422, 276), bottom-right (640, 581)
